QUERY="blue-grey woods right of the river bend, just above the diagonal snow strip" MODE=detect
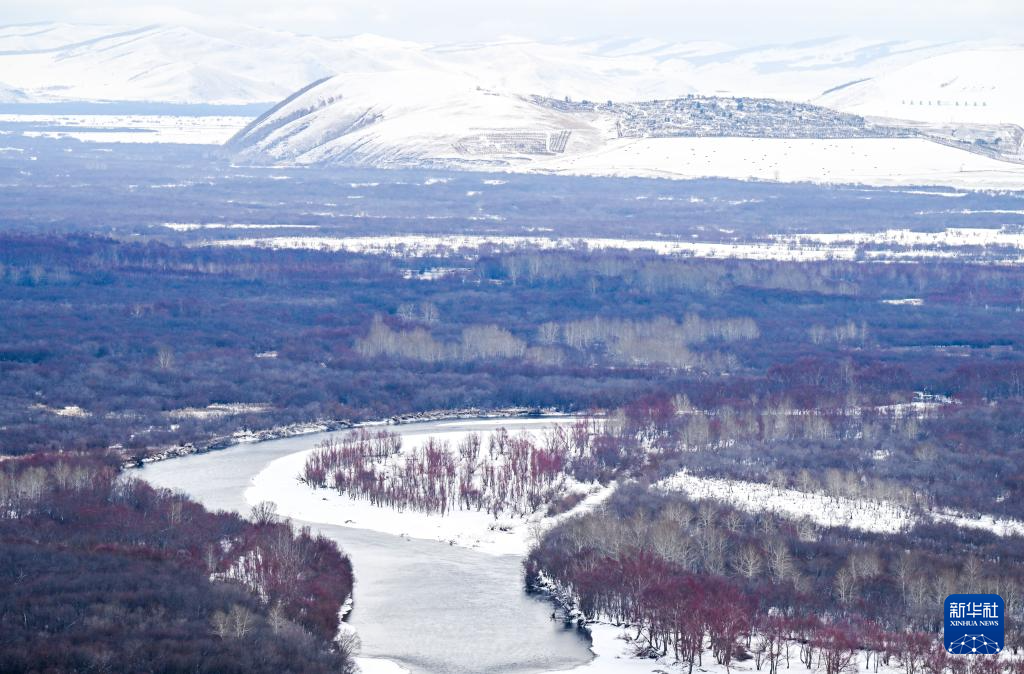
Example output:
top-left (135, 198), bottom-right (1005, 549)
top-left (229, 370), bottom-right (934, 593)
top-left (605, 391), bottom-right (1024, 519)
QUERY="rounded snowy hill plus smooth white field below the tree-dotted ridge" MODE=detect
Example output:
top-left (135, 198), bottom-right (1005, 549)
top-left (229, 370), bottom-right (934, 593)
top-left (230, 70), bottom-right (1024, 189)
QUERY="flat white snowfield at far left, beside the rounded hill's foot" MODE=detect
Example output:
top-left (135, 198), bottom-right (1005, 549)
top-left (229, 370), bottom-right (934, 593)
top-left (0, 114), bottom-right (251, 145)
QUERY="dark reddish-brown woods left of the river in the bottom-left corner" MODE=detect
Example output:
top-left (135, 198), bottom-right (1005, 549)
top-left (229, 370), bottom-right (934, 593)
top-left (0, 454), bottom-right (355, 674)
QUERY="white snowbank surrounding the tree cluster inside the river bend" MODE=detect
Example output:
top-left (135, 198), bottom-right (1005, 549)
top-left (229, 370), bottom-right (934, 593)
top-left (245, 418), bottom-right (611, 554)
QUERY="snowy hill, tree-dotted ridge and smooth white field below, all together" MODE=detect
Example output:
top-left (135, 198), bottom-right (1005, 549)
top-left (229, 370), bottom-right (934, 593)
top-left (227, 71), bottom-right (1024, 188)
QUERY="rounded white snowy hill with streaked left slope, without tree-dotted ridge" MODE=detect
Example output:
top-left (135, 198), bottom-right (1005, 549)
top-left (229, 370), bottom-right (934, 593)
top-left (229, 71), bottom-right (613, 166)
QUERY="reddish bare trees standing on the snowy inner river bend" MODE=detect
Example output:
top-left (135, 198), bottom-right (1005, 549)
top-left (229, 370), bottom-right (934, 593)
top-left (301, 419), bottom-right (600, 517)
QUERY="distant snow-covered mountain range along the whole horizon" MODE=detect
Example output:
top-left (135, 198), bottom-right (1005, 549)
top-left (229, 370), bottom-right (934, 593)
top-left (0, 22), bottom-right (1024, 124)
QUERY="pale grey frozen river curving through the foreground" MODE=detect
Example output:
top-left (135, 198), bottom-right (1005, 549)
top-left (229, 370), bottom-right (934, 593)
top-left (138, 419), bottom-right (592, 674)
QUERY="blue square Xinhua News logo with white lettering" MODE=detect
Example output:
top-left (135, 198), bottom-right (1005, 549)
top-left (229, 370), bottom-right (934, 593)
top-left (943, 594), bottom-right (1005, 656)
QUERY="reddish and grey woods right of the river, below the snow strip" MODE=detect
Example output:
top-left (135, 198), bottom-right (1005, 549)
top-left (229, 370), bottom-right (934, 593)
top-left (525, 482), bottom-right (1024, 674)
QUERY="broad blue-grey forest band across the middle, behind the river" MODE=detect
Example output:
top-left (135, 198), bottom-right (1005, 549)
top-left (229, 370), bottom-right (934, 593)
top-left (0, 234), bottom-right (1024, 456)
